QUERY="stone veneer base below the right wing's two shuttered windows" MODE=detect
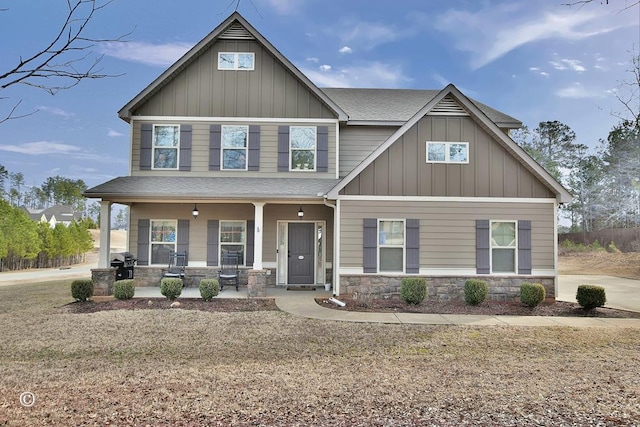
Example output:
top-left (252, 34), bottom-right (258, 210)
top-left (340, 274), bottom-right (555, 301)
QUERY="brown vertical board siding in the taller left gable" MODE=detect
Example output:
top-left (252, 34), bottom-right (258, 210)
top-left (132, 40), bottom-right (336, 118)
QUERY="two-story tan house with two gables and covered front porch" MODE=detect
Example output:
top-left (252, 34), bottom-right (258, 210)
top-left (85, 13), bottom-right (571, 298)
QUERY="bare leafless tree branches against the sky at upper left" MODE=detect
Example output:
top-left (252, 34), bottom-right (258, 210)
top-left (0, 0), bottom-right (130, 123)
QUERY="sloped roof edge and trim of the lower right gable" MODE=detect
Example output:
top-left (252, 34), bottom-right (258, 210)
top-left (327, 84), bottom-right (573, 203)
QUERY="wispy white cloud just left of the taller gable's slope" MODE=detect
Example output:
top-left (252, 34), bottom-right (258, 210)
top-left (100, 42), bottom-right (193, 67)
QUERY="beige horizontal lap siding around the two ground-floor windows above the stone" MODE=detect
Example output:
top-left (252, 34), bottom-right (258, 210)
top-left (340, 200), bottom-right (556, 270)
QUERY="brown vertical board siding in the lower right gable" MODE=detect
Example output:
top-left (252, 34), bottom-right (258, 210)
top-left (341, 116), bottom-right (555, 198)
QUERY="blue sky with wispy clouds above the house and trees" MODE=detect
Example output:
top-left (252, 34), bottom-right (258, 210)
top-left (0, 0), bottom-right (640, 191)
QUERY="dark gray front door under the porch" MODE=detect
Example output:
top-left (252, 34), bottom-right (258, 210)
top-left (287, 222), bottom-right (315, 285)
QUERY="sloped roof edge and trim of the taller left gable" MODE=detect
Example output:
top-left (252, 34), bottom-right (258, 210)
top-left (118, 12), bottom-right (347, 122)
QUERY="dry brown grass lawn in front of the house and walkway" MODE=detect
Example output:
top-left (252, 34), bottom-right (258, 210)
top-left (0, 283), bottom-right (640, 426)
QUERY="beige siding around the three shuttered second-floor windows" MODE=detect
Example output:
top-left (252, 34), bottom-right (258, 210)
top-left (131, 118), bottom-right (336, 179)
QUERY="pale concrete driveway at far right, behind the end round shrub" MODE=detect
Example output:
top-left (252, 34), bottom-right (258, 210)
top-left (557, 275), bottom-right (640, 312)
